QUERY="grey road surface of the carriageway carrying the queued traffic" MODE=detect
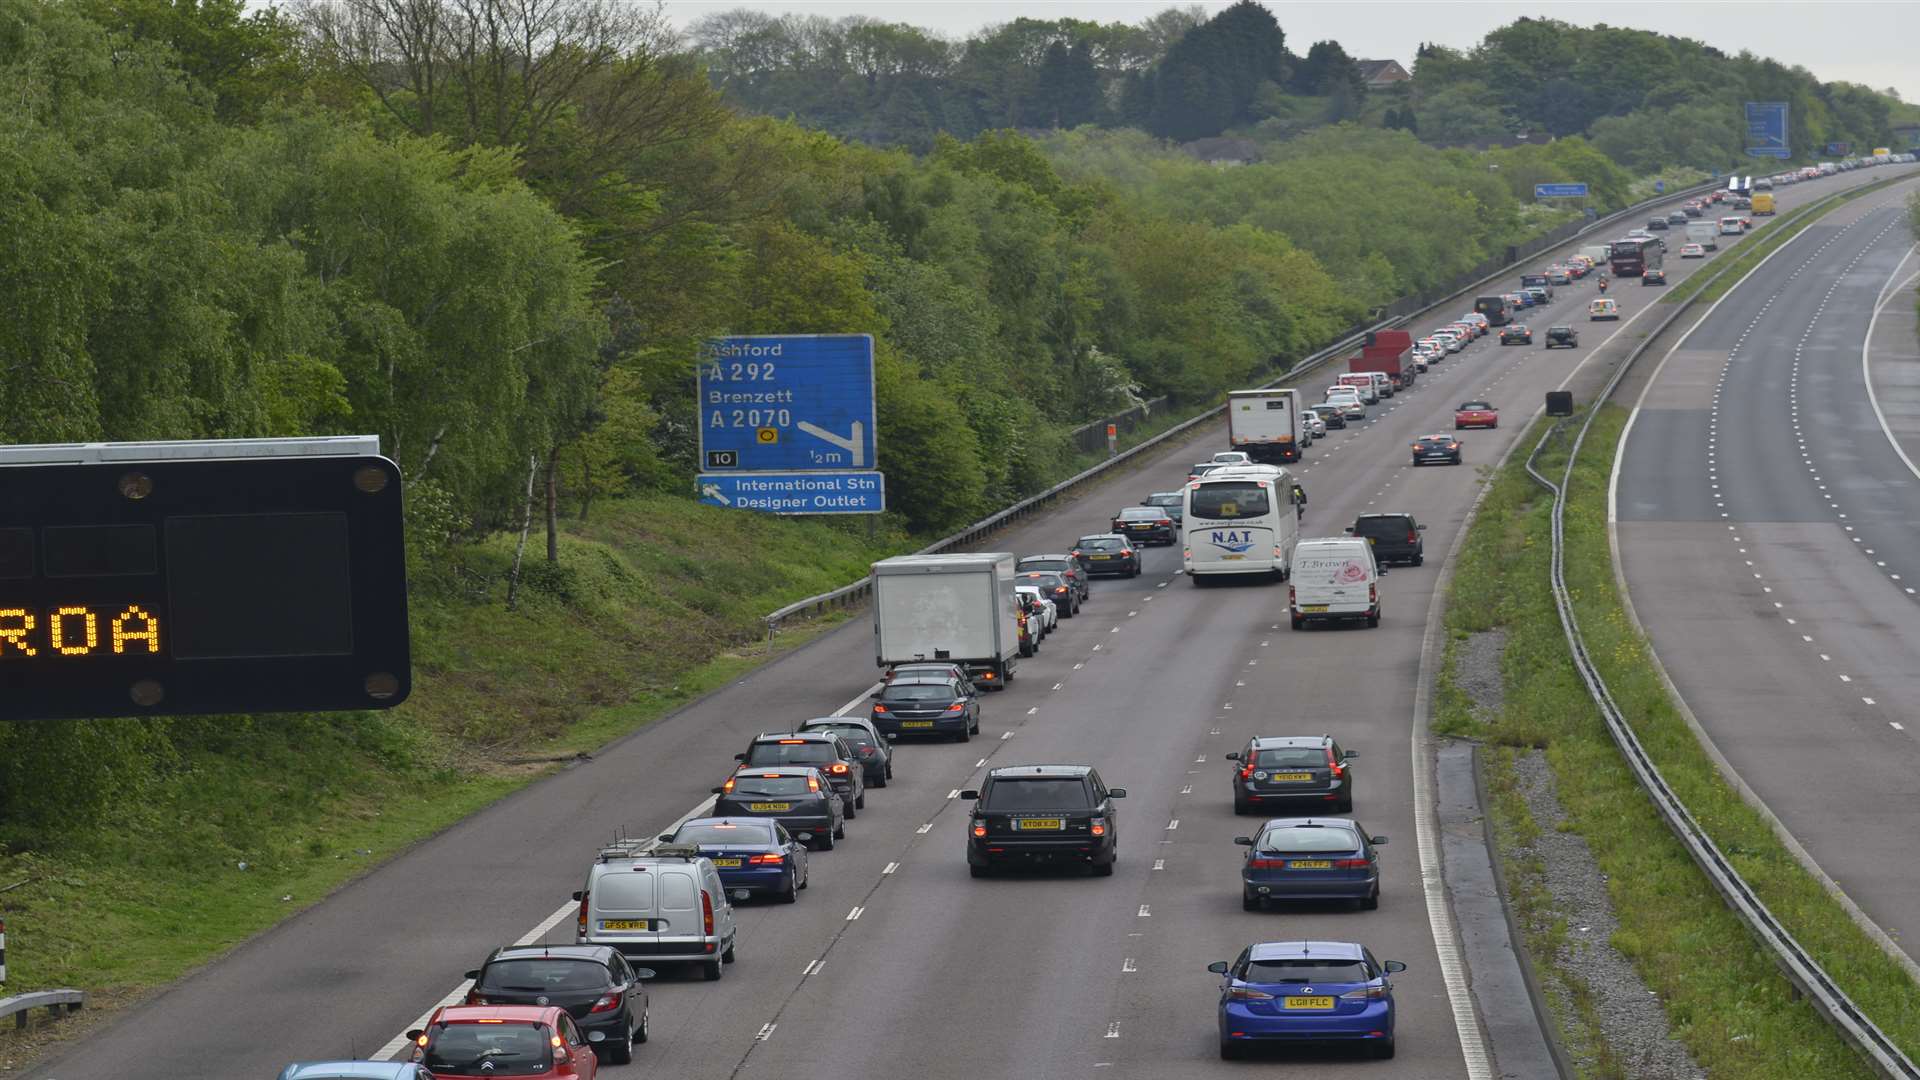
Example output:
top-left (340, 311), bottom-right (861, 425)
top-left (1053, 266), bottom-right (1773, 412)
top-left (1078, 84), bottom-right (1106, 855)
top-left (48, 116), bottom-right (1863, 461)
top-left (31, 161), bottom-right (1889, 1080)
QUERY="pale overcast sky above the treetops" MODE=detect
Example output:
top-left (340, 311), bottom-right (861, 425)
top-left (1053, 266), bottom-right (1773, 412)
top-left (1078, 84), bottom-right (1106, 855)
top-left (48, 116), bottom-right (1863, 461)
top-left (666, 0), bottom-right (1920, 102)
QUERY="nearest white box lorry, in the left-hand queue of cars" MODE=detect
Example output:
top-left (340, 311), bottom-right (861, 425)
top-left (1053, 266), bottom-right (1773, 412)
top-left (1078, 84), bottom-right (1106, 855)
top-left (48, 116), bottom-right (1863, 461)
top-left (872, 552), bottom-right (1020, 688)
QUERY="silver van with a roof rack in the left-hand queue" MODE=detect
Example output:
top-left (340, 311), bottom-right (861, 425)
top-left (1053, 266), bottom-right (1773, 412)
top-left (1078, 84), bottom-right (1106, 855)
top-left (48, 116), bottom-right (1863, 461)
top-left (574, 840), bottom-right (737, 980)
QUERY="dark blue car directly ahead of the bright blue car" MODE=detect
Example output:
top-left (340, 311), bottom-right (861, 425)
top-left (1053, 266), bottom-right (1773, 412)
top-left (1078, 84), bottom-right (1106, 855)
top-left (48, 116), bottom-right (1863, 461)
top-left (1233, 817), bottom-right (1386, 911)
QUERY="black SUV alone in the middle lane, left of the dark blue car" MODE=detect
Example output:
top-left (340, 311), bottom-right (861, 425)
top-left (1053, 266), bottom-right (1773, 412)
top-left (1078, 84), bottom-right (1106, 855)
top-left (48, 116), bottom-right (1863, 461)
top-left (960, 765), bottom-right (1127, 878)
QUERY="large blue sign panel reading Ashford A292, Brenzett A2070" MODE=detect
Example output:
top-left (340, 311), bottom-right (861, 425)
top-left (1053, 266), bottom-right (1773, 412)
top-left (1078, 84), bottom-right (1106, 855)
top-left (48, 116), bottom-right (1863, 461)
top-left (699, 334), bottom-right (874, 473)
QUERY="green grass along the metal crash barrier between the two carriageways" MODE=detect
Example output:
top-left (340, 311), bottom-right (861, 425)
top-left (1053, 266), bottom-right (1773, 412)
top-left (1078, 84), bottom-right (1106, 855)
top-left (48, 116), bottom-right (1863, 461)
top-left (1434, 405), bottom-right (1920, 1080)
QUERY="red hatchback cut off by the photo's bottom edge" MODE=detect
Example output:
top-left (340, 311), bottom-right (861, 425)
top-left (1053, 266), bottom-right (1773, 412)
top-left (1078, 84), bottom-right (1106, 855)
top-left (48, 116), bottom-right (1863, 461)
top-left (407, 1005), bottom-right (599, 1080)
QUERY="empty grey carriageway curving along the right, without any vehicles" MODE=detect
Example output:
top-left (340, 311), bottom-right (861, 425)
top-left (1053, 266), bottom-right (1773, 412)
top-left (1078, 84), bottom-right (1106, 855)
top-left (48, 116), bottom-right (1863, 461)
top-left (1611, 171), bottom-right (1920, 957)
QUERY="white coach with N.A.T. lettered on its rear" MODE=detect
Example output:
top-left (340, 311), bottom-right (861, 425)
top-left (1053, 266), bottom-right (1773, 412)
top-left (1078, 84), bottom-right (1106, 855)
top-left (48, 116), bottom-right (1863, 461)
top-left (1181, 465), bottom-right (1304, 584)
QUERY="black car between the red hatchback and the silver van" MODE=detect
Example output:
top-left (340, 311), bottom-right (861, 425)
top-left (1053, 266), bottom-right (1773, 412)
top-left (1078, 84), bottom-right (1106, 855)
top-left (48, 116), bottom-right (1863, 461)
top-left (467, 945), bottom-right (653, 1065)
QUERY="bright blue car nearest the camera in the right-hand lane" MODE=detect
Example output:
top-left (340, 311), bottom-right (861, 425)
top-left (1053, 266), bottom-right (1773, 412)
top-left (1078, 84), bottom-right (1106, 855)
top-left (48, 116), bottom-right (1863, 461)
top-left (1206, 942), bottom-right (1407, 1061)
